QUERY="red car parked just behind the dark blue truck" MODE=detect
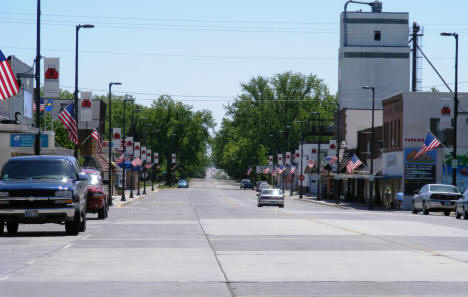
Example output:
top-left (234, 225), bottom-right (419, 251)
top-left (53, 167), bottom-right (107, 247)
top-left (82, 169), bottom-right (109, 220)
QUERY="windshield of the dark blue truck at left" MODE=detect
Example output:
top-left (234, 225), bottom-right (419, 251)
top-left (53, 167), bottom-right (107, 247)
top-left (2, 159), bottom-right (75, 180)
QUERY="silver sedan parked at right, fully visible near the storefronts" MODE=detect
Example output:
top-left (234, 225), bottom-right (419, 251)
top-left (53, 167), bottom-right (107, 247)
top-left (412, 184), bottom-right (462, 216)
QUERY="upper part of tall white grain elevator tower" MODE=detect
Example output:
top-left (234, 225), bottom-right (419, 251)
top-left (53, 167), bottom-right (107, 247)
top-left (338, 4), bottom-right (410, 109)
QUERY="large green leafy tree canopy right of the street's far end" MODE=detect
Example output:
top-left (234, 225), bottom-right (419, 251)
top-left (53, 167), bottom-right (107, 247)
top-left (212, 72), bottom-right (337, 178)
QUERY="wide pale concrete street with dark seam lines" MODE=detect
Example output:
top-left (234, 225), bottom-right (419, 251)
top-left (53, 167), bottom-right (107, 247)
top-left (0, 180), bottom-right (468, 297)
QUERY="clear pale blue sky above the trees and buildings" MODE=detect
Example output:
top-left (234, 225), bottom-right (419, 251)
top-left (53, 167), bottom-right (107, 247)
top-left (0, 0), bottom-right (468, 127)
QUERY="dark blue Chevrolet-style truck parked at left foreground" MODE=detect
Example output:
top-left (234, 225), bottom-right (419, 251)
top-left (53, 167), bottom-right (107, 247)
top-left (0, 155), bottom-right (87, 235)
